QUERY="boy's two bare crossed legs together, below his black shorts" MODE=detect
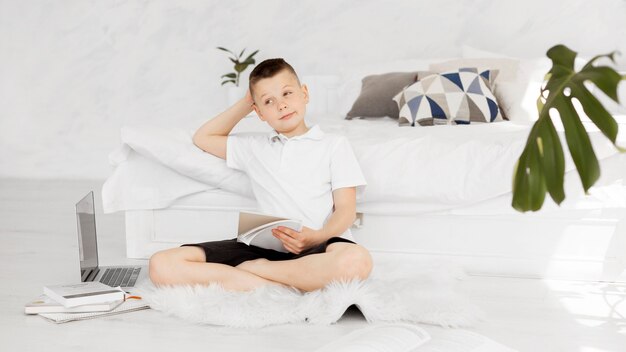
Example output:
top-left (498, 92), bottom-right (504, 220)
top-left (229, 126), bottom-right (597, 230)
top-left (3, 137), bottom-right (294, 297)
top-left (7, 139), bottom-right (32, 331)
top-left (150, 242), bottom-right (372, 291)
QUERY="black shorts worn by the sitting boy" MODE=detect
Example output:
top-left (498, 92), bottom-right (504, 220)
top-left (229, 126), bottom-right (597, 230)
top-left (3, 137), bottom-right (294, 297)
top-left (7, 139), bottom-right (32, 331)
top-left (181, 237), bottom-right (355, 266)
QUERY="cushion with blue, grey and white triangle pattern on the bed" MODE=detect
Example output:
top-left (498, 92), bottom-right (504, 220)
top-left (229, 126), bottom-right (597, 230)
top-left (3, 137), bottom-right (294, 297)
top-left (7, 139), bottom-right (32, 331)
top-left (393, 67), bottom-right (503, 126)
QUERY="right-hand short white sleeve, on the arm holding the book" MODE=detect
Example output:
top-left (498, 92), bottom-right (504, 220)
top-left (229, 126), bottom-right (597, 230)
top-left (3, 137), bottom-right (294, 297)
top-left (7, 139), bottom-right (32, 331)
top-left (330, 136), bottom-right (367, 191)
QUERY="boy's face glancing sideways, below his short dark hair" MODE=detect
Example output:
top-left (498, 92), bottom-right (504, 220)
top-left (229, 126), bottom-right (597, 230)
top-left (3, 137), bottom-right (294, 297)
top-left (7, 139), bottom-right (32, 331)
top-left (253, 70), bottom-right (309, 137)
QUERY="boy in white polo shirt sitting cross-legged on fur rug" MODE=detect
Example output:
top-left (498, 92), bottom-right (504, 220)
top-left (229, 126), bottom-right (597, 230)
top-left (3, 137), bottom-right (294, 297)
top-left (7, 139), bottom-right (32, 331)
top-left (150, 59), bottom-right (372, 291)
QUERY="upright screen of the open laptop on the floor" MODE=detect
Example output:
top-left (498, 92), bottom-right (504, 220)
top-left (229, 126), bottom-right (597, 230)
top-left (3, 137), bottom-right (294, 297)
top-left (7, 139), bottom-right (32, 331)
top-left (76, 191), bottom-right (98, 280)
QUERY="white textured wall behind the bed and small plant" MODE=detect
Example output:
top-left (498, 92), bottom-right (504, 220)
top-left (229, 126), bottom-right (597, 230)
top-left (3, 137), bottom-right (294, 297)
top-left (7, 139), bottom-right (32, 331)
top-left (0, 0), bottom-right (626, 179)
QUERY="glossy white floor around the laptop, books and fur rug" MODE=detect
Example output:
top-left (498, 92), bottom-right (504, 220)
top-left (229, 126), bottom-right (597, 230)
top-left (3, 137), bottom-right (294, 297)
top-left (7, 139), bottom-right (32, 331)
top-left (0, 180), bottom-right (626, 352)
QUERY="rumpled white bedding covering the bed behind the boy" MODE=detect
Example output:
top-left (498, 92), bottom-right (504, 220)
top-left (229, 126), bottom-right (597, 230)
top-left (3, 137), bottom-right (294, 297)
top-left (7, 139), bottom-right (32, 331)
top-left (102, 116), bottom-right (616, 213)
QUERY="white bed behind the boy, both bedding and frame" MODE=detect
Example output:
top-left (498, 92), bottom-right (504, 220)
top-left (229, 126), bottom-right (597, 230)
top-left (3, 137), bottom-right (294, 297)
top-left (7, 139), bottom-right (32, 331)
top-left (103, 111), bottom-right (626, 280)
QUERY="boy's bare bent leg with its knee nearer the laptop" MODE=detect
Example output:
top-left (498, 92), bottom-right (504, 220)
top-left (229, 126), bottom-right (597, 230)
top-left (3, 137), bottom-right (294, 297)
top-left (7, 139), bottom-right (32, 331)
top-left (150, 246), bottom-right (277, 291)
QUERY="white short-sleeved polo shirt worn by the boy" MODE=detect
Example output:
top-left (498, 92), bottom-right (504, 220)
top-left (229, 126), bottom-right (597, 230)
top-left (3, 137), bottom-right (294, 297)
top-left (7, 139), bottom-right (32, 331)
top-left (226, 125), bottom-right (366, 240)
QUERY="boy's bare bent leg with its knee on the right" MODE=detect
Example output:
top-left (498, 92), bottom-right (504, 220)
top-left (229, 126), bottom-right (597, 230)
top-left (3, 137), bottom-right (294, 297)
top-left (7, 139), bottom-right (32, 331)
top-left (237, 242), bottom-right (372, 291)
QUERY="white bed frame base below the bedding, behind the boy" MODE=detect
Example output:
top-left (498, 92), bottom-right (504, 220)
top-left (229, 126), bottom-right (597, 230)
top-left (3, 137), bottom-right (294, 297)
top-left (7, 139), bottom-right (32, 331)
top-left (126, 197), bottom-right (626, 281)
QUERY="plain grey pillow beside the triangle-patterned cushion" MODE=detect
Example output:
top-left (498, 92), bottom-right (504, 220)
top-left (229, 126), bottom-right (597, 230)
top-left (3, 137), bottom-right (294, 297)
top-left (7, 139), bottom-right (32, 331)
top-left (346, 72), bottom-right (417, 120)
